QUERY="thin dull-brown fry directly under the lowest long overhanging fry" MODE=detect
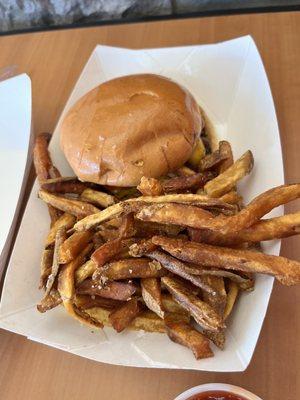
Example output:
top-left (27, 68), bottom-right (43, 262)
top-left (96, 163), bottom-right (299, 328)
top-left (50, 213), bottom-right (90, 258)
top-left (147, 250), bottom-right (217, 296)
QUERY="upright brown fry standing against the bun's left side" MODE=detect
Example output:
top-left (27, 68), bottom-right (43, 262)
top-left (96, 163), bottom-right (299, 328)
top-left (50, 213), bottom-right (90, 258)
top-left (33, 133), bottom-right (52, 183)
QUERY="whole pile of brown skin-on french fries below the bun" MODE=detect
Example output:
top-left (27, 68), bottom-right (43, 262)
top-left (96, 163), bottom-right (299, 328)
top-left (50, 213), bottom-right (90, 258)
top-left (34, 134), bottom-right (300, 359)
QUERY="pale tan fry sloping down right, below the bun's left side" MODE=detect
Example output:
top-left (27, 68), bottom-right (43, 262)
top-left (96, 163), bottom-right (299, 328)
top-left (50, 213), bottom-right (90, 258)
top-left (39, 190), bottom-right (99, 218)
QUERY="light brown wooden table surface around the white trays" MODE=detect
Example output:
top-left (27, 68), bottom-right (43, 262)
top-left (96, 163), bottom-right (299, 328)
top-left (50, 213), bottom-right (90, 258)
top-left (0, 13), bottom-right (300, 400)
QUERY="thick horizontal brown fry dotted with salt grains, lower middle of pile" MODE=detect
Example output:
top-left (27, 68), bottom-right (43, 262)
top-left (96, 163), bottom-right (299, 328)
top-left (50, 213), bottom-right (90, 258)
top-left (100, 258), bottom-right (166, 280)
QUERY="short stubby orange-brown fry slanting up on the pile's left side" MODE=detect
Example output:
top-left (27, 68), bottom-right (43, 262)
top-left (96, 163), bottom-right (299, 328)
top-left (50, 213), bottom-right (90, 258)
top-left (58, 231), bottom-right (93, 264)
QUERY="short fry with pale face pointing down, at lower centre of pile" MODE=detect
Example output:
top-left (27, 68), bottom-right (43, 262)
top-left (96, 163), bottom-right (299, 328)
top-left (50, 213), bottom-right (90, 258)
top-left (141, 278), bottom-right (165, 318)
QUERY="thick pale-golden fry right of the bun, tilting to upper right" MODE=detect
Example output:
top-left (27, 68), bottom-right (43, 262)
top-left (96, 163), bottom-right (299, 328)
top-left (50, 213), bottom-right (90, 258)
top-left (204, 150), bottom-right (254, 197)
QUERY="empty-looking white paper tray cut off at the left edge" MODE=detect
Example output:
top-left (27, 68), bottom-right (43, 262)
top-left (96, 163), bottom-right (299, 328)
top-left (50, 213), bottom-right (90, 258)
top-left (0, 74), bottom-right (31, 254)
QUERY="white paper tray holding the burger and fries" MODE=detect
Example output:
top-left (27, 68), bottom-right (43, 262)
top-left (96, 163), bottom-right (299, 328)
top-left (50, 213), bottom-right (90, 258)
top-left (0, 36), bottom-right (283, 371)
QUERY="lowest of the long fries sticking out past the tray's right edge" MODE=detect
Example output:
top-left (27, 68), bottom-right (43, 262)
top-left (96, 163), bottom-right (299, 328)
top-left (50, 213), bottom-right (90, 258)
top-left (152, 236), bottom-right (300, 285)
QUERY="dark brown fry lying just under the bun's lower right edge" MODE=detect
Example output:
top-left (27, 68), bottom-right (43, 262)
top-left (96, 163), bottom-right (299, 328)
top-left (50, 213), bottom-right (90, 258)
top-left (162, 172), bottom-right (215, 193)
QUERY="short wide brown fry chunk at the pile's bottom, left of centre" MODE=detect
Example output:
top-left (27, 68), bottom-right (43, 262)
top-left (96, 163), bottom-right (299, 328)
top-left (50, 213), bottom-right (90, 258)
top-left (108, 299), bottom-right (142, 332)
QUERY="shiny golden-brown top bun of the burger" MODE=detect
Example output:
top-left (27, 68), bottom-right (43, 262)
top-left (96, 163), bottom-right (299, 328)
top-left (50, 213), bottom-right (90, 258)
top-left (60, 74), bottom-right (203, 186)
